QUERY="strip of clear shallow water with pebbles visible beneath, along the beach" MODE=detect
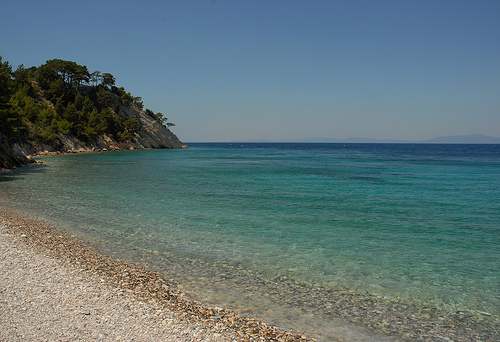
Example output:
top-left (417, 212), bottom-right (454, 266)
top-left (1, 203), bottom-right (500, 342)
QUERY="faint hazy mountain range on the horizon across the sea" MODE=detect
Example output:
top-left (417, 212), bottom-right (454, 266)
top-left (299, 134), bottom-right (500, 144)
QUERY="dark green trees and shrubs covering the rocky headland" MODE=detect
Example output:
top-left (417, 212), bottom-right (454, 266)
top-left (0, 56), bottom-right (173, 149)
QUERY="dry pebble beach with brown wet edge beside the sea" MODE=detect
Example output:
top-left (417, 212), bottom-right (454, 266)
top-left (0, 208), bottom-right (307, 341)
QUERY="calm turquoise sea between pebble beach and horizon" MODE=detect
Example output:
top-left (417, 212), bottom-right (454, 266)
top-left (0, 143), bottom-right (500, 341)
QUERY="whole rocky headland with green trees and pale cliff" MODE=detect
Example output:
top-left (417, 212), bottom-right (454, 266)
top-left (0, 56), bottom-right (182, 168)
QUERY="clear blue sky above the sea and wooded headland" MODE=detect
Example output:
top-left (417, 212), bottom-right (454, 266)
top-left (0, 0), bottom-right (500, 142)
